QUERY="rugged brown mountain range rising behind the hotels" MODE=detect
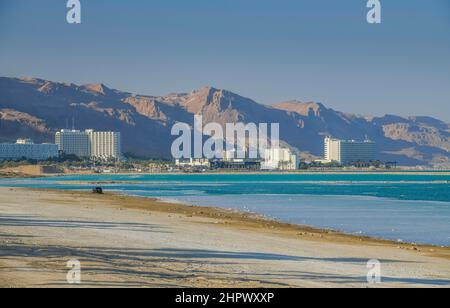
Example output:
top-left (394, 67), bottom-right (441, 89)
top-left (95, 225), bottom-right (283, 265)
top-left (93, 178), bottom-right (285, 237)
top-left (0, 78), bottom-right (450, 166)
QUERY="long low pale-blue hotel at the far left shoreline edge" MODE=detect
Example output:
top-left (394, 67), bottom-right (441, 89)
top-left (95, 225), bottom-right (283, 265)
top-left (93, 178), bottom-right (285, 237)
top-left (0, 139), bottom-right (59, 160)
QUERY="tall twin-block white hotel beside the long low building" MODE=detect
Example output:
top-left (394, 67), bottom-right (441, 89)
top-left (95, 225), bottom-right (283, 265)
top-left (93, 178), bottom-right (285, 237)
top-left (55, 129), bottom-right (122, 160)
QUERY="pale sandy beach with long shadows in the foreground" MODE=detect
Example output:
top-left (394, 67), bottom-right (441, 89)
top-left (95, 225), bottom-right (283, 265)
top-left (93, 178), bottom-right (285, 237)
top-left (0, 188), bottom-right (450, 287)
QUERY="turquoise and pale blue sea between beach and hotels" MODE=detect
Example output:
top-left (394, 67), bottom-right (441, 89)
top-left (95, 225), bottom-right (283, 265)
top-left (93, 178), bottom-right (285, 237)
top-left (0, 174), bottom-right (450, 246)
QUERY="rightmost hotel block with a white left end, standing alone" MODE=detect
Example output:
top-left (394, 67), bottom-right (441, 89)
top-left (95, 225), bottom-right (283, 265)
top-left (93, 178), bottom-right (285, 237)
top-left (325, 137), bottom-right (375, 165)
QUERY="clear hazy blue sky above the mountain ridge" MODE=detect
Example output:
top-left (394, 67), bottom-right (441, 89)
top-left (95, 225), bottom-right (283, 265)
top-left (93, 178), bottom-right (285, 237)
top-left (0, 0), bottom-right (450, 122)
